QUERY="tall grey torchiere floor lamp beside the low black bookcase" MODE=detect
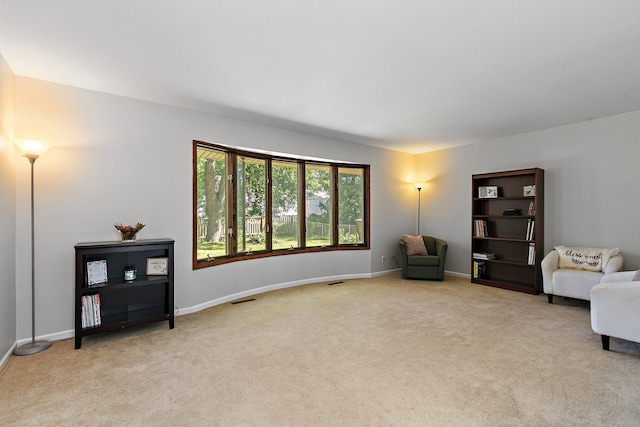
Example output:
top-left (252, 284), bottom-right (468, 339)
top-left (13, 139), bottom-right (51, 356)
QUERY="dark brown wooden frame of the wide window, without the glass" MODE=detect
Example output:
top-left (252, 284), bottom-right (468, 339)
top-left (192, 140), bottom-right (371, 270)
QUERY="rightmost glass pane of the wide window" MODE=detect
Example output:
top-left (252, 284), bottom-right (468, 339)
top-left (338, 168), bottom-right (365, 244)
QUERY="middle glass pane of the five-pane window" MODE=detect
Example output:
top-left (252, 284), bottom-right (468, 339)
top-left (271, 161), bottom-right (300, 250)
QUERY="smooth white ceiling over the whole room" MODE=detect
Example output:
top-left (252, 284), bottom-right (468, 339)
top-left (0, 0), bottom-right (640, 153)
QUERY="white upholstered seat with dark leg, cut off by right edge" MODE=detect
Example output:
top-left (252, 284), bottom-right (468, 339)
top-left (591, 271), bottom-right (640, 350)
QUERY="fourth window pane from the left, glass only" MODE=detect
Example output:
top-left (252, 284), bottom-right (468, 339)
top-left (305, 165), bottom-right (331, 247)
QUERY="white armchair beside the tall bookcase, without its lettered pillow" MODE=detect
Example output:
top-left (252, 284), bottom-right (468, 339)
top-left (540, 246), bottom-right (624, 304)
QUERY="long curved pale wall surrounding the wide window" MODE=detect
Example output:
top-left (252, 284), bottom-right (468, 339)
top-left (15, 76), bottom-right (416, 339)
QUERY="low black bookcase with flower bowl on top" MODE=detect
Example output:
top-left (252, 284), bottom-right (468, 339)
top-left (75, 239), bottom-right (174, 349)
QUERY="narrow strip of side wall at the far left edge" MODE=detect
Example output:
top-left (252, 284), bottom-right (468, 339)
top-left (0, 55), bottom-right (16, 360)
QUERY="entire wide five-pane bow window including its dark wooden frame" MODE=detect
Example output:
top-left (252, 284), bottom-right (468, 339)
top-left (193, 141), bottom-right (369, 268)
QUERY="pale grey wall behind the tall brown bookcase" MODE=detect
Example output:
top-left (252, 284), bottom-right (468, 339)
top-left (416, 111), bottom-right (640, 274)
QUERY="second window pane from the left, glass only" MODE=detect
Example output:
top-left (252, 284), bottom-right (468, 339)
top-left (236, 156), bottom-right (267, 252)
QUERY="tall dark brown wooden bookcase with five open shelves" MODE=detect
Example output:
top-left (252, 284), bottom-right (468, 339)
top-left (471, 168), bottom-right (544, 294)
